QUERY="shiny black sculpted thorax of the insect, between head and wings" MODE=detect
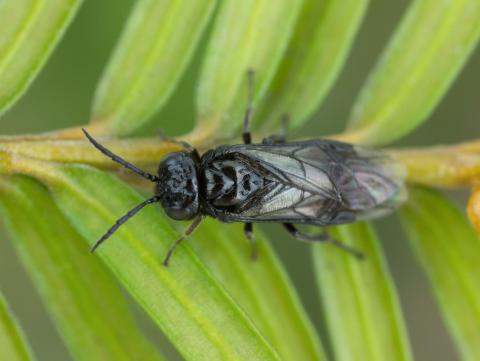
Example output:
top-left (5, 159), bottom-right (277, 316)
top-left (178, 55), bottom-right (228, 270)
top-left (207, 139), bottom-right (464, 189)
top-left (204, 159), bottom-right (269, 208)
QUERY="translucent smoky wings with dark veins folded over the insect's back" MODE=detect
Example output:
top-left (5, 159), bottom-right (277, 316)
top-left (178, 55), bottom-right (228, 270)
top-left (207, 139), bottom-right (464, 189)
top-left (208, 140), bottom-right (406, 225)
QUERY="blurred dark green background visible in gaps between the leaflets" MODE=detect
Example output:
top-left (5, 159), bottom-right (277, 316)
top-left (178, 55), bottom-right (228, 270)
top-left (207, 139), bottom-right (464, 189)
top-left (0, 0), bottom-right (480, 361)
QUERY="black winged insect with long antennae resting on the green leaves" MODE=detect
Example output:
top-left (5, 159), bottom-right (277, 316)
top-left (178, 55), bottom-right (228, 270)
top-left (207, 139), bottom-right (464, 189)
top-left (83, 72), bottom-right (405, 266)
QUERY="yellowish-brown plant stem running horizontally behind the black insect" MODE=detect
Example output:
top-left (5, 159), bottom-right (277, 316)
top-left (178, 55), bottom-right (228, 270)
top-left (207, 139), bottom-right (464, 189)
top-left (0, 128), bottom-right (480, 188)
